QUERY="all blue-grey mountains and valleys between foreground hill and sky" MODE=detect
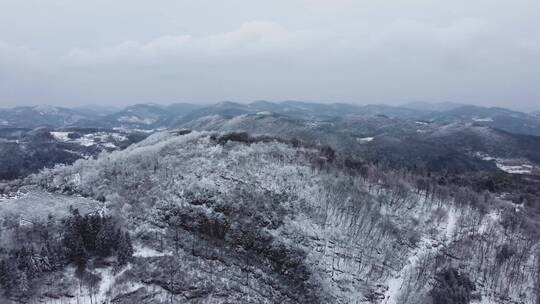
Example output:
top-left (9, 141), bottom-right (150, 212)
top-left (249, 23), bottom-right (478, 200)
top-left (0, 101), bottom-right (540, 177)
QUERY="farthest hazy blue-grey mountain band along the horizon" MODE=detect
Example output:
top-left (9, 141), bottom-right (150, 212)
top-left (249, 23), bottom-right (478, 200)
top-left (4, 101), bottom-right (540, 136)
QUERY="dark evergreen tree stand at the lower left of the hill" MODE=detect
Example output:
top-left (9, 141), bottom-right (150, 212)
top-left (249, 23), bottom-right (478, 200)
top-left (0, 209), bottom-right (133, 298)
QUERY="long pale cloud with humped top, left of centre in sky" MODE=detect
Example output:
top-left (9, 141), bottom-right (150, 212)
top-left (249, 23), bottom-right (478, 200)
top-left (66, 21), bottom-right (322, 66)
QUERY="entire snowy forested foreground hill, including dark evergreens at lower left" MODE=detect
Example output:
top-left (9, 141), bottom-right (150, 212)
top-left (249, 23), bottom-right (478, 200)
top-left (0, 130), bottom-right (540, 304)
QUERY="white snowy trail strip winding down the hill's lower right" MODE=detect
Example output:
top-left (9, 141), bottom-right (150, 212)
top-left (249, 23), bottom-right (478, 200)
top-left (383, 209), bottom-right (457, 304)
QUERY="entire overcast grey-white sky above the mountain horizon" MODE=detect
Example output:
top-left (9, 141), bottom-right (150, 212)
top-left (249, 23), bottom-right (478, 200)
top-left (0, 0), bottom-right (540, 109)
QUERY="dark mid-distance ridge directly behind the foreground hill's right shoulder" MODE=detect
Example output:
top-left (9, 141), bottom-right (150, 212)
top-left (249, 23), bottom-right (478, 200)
top-left (177, 112), bottom-right (540, 176)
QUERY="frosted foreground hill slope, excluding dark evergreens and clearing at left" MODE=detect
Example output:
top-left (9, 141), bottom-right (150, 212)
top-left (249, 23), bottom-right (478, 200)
top-left (5, 132), bottom-right (539, 304)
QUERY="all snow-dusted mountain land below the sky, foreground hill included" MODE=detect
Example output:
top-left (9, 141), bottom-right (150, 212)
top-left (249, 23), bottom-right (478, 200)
top-left (0, 101), bottom-right (540, 304)
